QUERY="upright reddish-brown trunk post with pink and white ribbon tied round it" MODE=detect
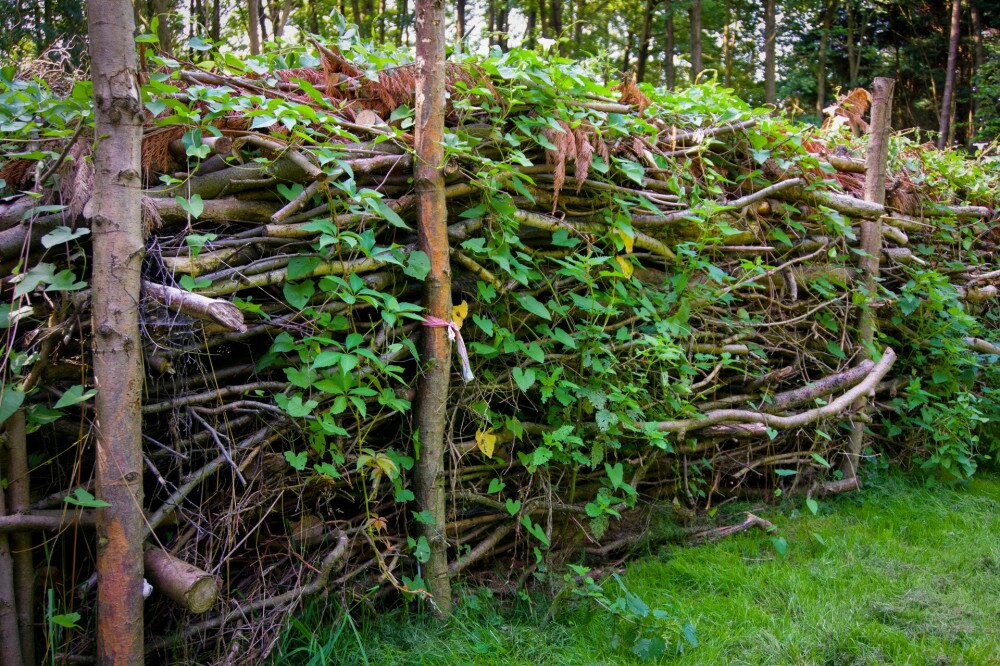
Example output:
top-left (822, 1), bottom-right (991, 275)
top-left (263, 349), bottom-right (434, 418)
top-left (413, 0), bottom-right (452, 617)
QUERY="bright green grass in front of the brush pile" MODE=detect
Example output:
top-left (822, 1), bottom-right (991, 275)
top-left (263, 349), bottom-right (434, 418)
top-left (279, 477), bottom-right (1000, 666)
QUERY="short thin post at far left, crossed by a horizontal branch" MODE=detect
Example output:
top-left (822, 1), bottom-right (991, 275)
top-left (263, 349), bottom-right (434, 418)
top-left (5, 409), bottom-right (35, 664)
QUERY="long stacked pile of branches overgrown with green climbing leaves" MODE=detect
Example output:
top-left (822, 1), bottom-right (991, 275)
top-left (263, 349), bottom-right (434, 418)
top-left (0, 41), bottom-right (1000, 663)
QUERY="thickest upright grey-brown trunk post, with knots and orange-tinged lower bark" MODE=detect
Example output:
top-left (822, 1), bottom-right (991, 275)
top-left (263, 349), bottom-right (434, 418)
top-left (86, 0), bottom-right (146, 664)
